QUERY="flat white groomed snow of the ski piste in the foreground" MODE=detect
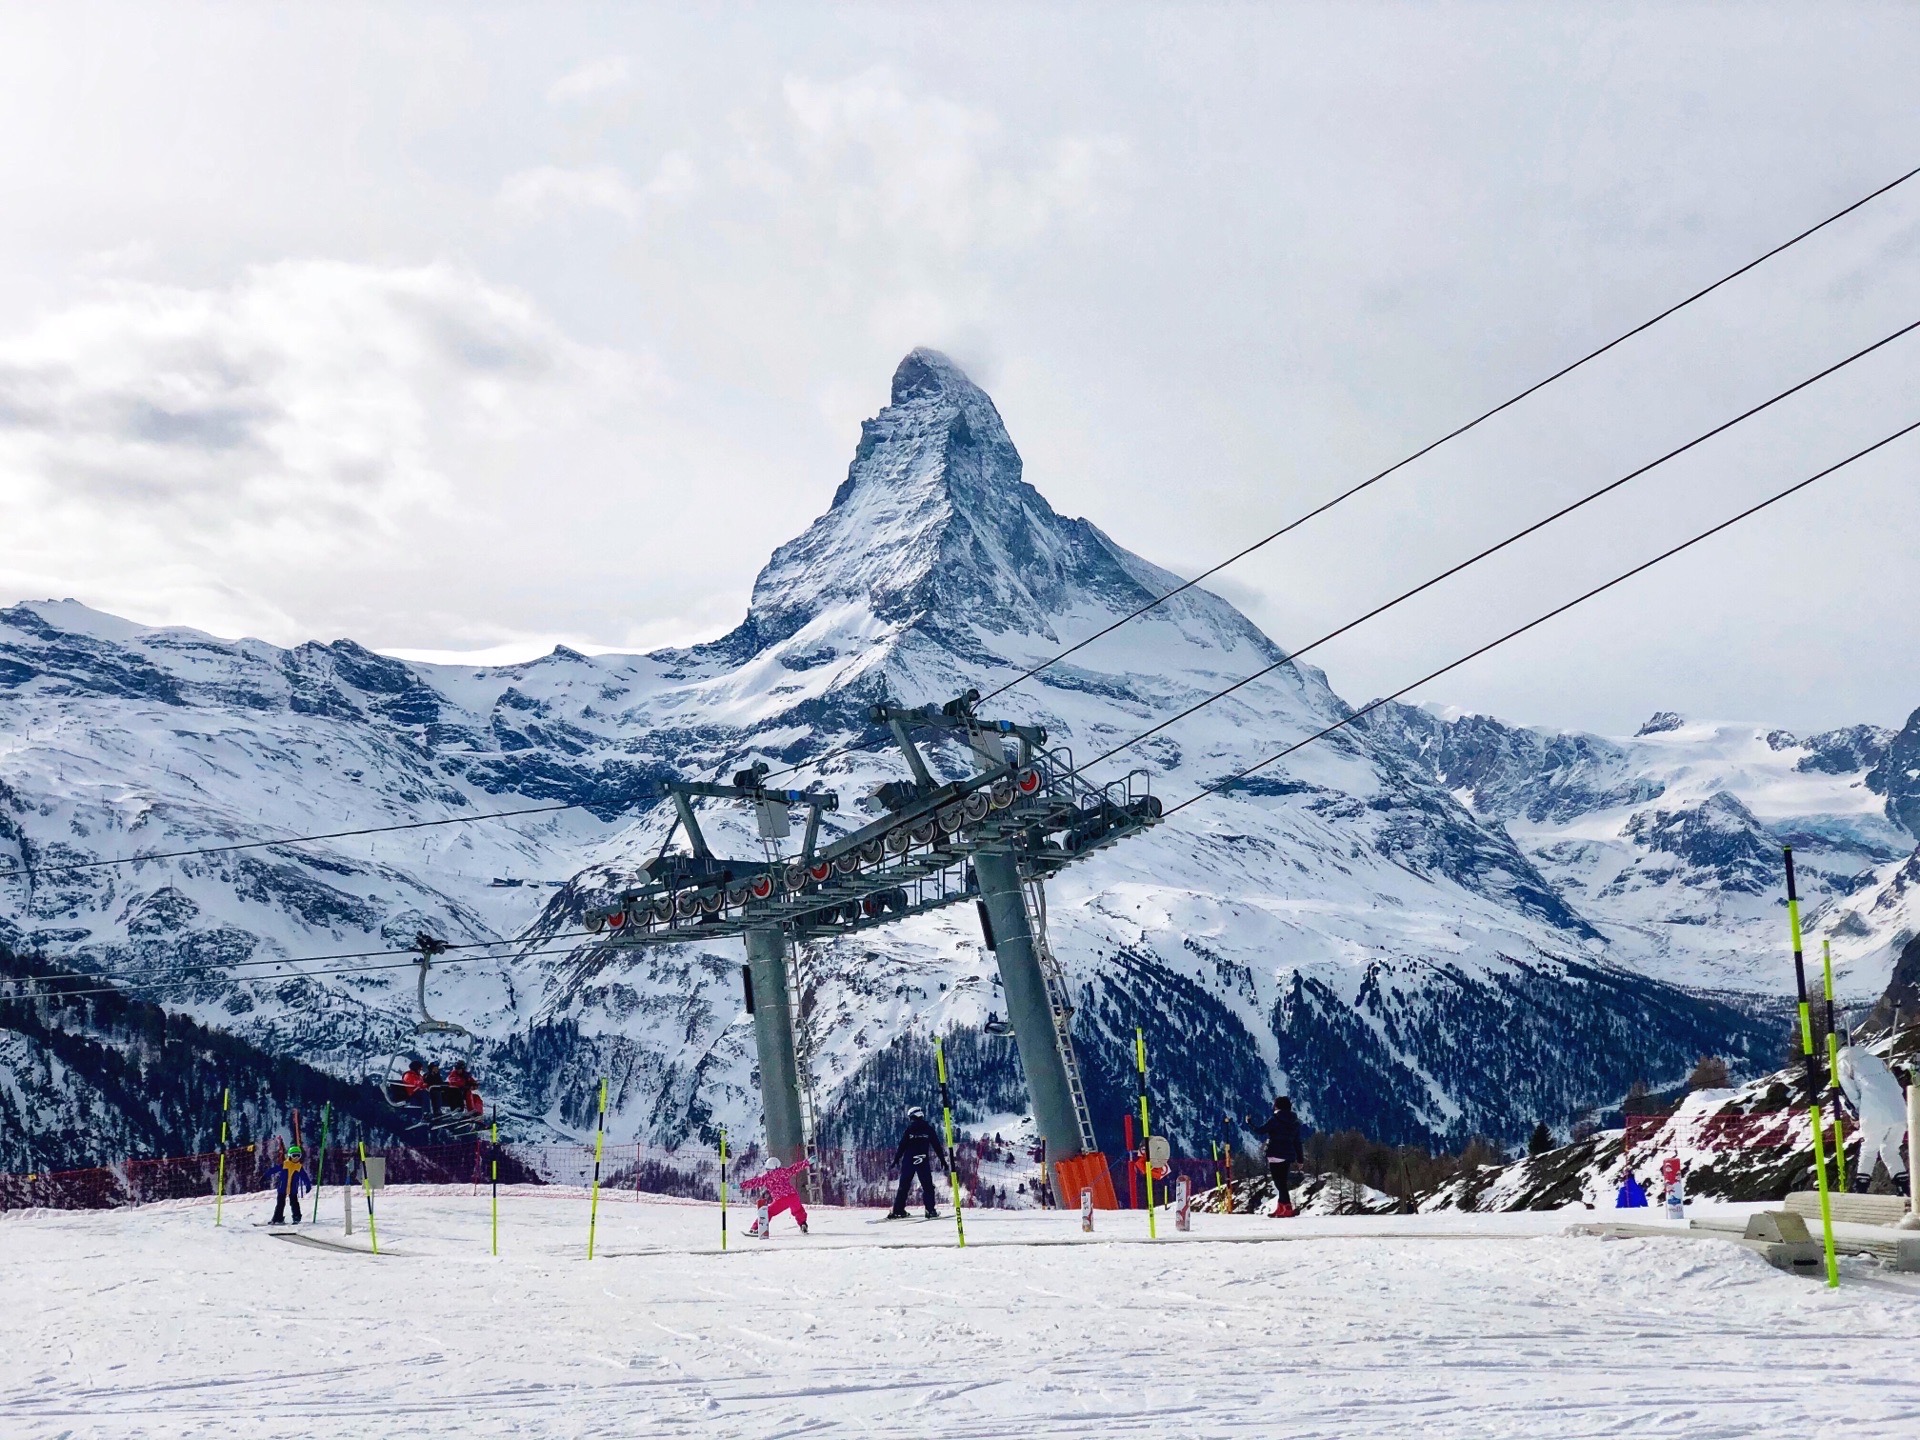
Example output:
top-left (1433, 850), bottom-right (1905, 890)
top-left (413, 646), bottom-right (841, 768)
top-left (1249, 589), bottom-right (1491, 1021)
top-left (0, 1188), bottom-right (1920, 1440)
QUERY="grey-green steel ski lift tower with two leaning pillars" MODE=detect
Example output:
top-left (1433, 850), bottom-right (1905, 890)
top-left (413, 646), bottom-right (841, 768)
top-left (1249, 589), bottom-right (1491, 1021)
top-left (584, 691), bottom-right (1160, 1190)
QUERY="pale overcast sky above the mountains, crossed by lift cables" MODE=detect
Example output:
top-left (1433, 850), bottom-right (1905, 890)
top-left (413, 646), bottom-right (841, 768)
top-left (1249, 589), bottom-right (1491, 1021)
top-left (0, 4), bottom-right (1920, 732)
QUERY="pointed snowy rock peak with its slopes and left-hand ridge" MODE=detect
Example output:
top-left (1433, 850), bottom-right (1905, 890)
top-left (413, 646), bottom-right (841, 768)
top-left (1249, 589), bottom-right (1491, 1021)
top-left (0, 351), bottom-right (1850, 1175)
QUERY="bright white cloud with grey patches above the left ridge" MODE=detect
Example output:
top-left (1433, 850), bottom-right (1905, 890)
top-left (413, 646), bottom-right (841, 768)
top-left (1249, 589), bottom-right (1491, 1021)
top-left (0, 261), bottom-right (647, 637)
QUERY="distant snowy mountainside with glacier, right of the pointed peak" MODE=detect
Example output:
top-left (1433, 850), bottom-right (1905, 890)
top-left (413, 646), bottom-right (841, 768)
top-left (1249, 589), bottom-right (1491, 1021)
top-left (1367, 705), bottom-right (1920, 998)
